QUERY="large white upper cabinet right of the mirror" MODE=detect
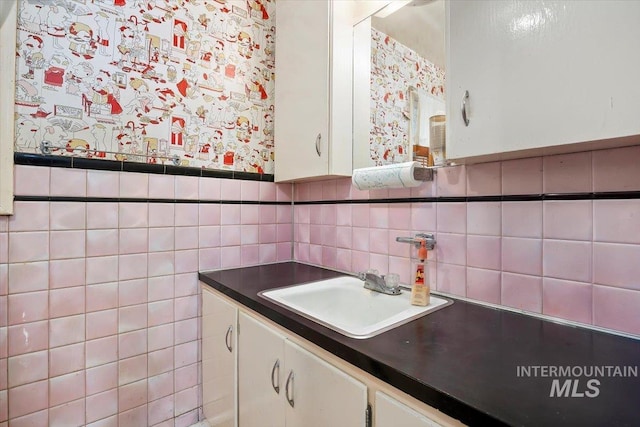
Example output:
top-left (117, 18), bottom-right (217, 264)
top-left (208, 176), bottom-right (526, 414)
top-left (446, 0), bottom-right (640, 161)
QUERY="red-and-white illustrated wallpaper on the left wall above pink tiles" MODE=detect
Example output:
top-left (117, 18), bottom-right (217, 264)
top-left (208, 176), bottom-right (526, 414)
top-left (15, 0), bottom-right (275, 173)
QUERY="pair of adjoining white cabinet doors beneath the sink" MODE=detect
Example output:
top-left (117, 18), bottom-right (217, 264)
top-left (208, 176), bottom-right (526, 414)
top-left (238, 312), bottom-right (367, 427)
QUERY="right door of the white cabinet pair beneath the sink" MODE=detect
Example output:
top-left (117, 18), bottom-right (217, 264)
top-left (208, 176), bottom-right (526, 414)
top-left (283, 341), bottom-right (367, 427)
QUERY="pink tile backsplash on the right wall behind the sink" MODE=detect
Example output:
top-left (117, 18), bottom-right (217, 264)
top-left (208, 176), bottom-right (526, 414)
top-left (294, 146), bottom-right (640, 336)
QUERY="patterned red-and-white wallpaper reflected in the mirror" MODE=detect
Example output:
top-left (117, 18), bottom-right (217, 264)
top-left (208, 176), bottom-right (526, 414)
top-left (369, 28), bottom-right (445, 165)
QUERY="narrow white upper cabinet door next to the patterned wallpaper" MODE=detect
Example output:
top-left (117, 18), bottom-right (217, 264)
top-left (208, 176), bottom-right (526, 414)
top-left (274, 0), bottom-right (328, 181)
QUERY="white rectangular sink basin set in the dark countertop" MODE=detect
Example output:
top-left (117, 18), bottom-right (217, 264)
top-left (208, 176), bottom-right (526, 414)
top-left (259, 276), bottom-right (453, 339)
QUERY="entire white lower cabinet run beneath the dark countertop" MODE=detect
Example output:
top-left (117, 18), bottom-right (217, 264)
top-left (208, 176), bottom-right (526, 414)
top-left (200, 283), bottom-right (462, 427)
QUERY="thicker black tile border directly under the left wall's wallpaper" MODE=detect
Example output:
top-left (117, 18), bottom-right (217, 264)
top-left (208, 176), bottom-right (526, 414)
top-left (13, 153), bottom-right (274, 182)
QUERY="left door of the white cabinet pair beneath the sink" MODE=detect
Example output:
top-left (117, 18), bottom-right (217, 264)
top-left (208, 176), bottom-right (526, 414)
top-left (238, 313), bottom-right (285, 427)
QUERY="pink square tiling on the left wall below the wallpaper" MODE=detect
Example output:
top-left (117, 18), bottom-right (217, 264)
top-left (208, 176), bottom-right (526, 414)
top-left (0, 165), bottom-right (292, 427)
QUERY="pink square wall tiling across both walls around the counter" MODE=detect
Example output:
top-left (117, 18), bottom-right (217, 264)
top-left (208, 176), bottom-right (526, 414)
top-left (6, 147), bottom-right (640, 426)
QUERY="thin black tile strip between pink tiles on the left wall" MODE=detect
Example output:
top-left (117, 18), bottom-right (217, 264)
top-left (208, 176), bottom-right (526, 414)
top-left (13, 196), bottom-right (291, 206)
